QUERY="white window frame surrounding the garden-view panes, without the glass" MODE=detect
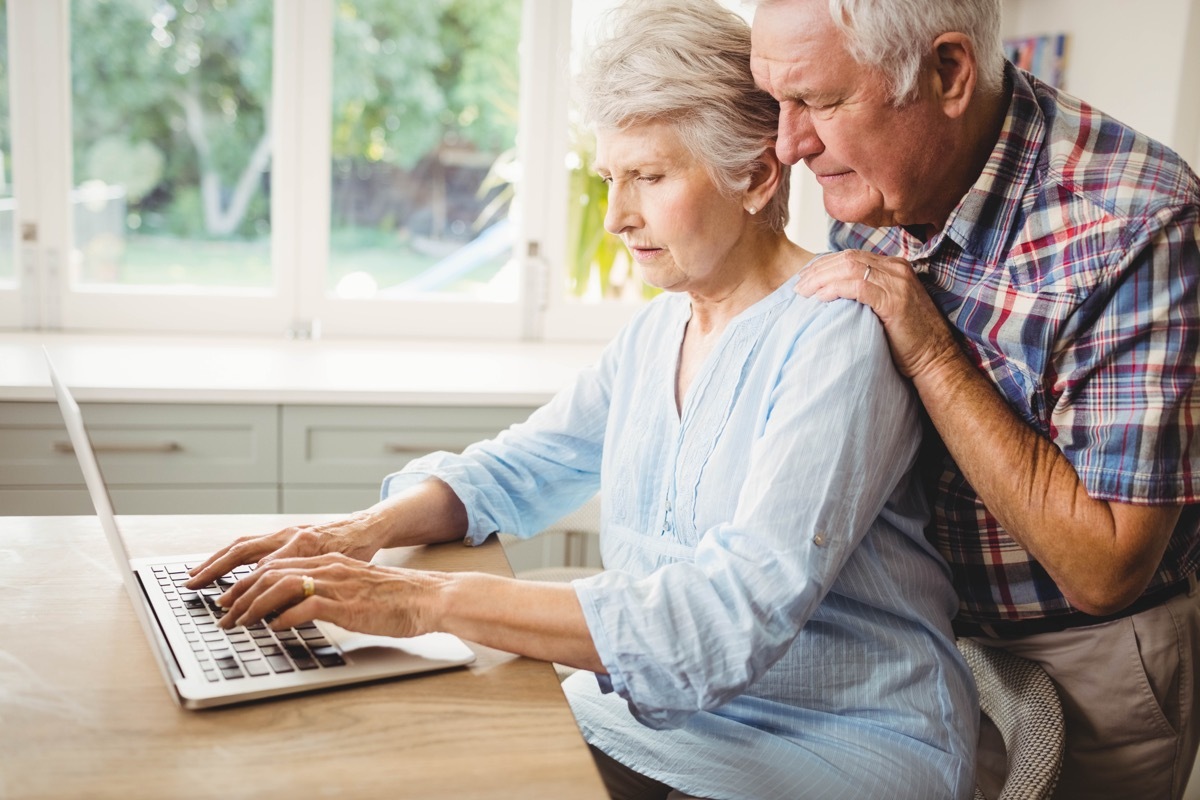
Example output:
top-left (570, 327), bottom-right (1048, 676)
top-left (0, 0), bottom-right (631, 339)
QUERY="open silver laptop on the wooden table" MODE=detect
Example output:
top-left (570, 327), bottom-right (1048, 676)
top-left (46, 353), bottom-right (475, 709)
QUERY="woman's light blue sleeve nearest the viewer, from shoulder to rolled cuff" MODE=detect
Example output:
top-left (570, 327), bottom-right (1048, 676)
top-left (574, 301), bottom-right (920, 728)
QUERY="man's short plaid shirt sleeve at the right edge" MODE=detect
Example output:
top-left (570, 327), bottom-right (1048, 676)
top-left (1051, 205), bottom-right (1200, 505)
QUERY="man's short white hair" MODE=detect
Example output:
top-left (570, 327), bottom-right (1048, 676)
top-left (829, 0), bottom-right (1004, 104)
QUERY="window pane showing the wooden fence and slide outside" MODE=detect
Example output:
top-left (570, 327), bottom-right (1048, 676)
top-left (325, 0), bottom-right (521, 302)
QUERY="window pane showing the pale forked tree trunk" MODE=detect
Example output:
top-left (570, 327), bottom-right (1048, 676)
top-left (70, 0), bottom-right (274, 291)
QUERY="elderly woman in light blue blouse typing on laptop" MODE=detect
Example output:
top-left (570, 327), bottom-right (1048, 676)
top-left (192, 0), bottom-right (977, 800)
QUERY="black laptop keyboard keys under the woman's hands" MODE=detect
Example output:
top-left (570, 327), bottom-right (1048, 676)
top-left (154, 564), bottom-right (346, 682)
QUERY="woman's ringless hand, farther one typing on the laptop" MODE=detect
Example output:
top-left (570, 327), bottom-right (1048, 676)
top-left (187, 511), bottom-right (379, 589)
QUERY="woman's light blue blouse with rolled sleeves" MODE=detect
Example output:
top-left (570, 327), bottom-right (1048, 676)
top-left (384, 279), bottom-right (978, 800)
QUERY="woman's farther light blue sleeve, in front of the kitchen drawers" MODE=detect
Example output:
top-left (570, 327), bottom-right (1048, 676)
top-left (382, 337), bottom-right (620, 545)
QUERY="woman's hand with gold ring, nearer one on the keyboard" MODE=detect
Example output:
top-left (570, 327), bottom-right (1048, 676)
top-left (217, 553), bottom-right (446, 637)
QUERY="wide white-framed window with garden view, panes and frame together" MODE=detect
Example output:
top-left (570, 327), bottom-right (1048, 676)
top-left (0, 0), bottom-right (676, 339)
